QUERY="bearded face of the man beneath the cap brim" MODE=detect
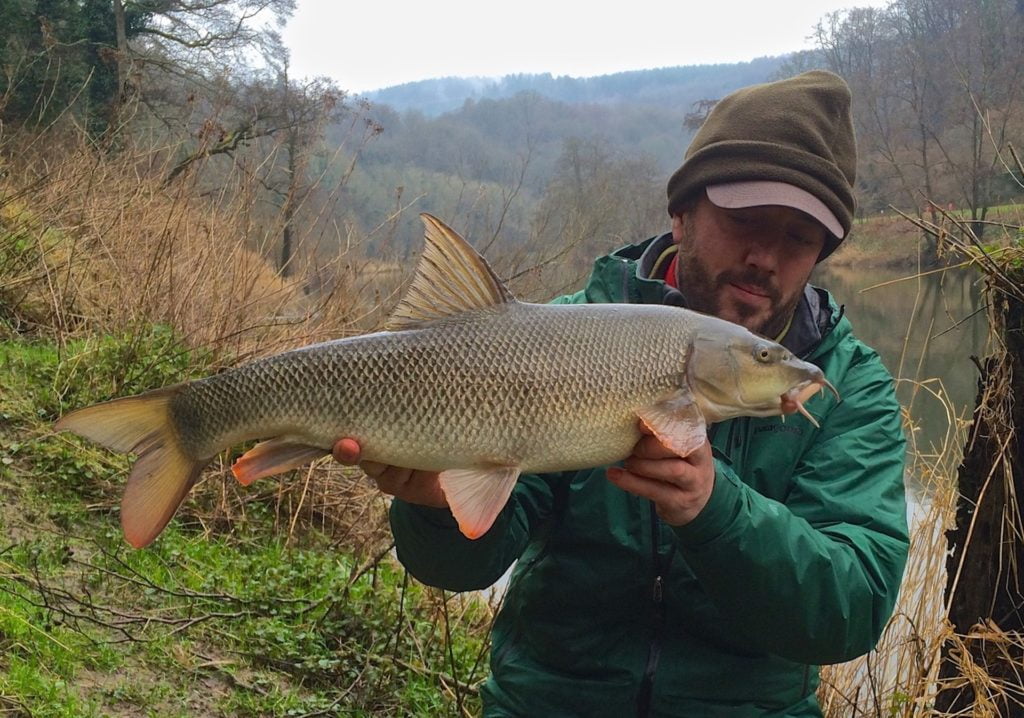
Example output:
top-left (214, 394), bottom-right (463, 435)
top-left (672, 195), bottom-right (827, 338)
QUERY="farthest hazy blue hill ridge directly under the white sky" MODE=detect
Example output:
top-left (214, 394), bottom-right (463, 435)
top-left (365, 56), bottom-right (787, 117)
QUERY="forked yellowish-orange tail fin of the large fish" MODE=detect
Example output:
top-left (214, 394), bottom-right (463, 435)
top-left (55, 384), bottom-right (206, 548)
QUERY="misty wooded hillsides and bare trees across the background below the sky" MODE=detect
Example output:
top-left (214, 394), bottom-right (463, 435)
top-left (6, 0), bottom-right (1024, 282)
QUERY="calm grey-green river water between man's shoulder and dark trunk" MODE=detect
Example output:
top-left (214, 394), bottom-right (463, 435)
top-left (811, 262), bottom-right (988, 452)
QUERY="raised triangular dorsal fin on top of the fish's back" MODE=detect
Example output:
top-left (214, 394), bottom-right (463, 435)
top-left (385, 213), bottom-right (515, 332)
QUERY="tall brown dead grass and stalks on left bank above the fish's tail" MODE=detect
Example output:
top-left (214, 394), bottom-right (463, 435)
top-left (0, 121), bottom-right (395, 361)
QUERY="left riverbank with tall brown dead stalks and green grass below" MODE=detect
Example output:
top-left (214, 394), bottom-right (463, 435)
top-left (0, 137), bottom-right (493, 718)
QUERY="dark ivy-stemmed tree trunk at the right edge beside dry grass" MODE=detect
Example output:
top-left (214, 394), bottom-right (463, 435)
top-left (936, 268), bottom-right (1024, 716)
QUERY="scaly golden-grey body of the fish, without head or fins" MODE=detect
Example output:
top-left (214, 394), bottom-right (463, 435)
top-left (172, 304), bottom-right (690, 471)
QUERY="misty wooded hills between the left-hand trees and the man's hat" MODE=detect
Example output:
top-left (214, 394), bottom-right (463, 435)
top-left (329, 55), bottom-right (799, 249)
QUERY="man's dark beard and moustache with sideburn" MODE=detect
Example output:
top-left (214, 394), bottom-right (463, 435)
top-left (676, 231), bottom-right (803, 339)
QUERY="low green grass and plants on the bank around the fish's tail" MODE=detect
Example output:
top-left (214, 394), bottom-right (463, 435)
top-left (0, 328), bottom-right (490, 718)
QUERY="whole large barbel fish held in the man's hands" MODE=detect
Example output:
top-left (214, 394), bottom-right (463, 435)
top-left (54, 214), bottom-right (839, 548)
